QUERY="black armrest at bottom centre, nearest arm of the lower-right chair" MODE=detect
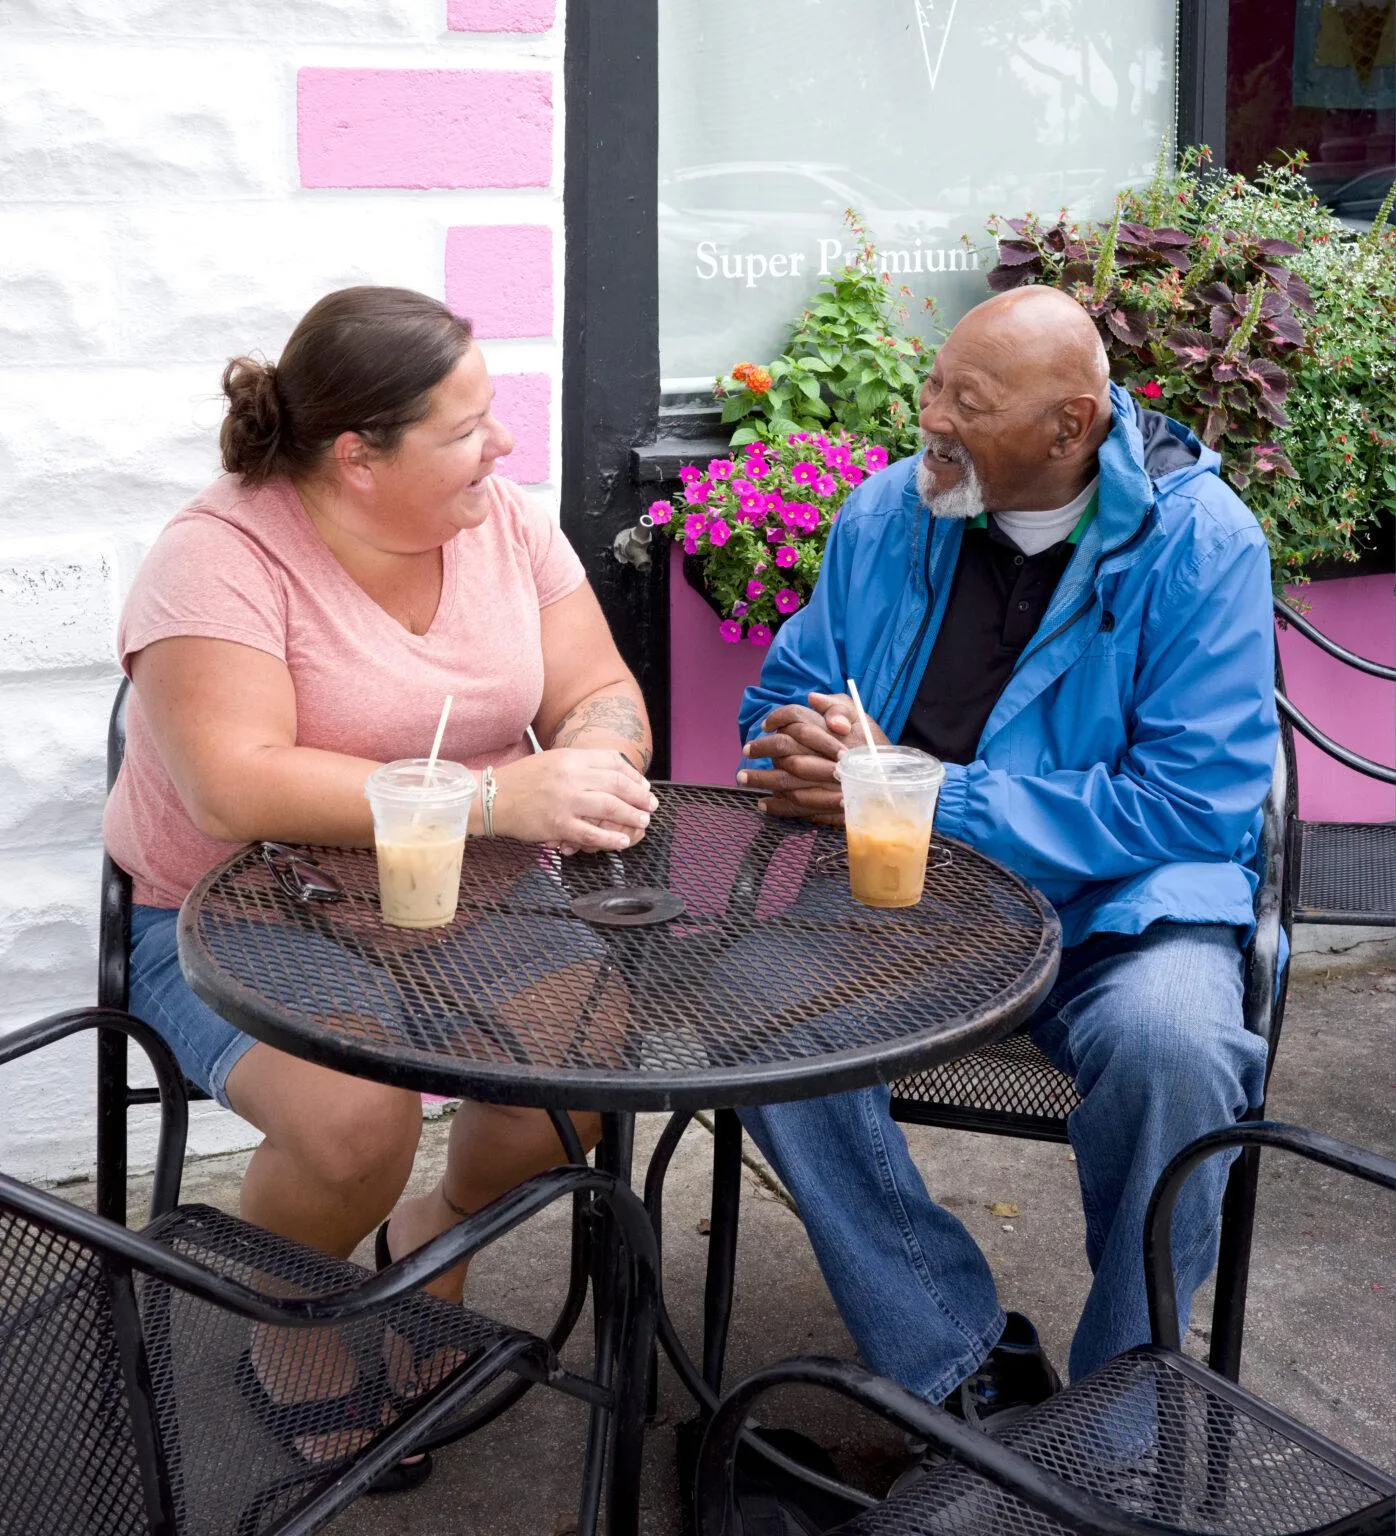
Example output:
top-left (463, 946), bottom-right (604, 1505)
top-left (697, 1355), bottom-right (1210, 1536)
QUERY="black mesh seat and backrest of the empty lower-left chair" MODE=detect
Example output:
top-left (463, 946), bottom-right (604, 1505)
top-left (0, 1206), bottom-right (551, 1536)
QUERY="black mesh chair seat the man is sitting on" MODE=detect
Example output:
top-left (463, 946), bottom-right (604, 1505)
top-left (892, 1032), bottom-right (1081, 1141)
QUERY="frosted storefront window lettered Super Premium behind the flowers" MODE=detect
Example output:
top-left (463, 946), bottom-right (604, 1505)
top-left (659, 0), bottom-right (1179, 393)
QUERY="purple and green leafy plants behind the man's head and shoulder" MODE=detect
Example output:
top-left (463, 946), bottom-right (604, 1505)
top-left (989, 151), bottom-right (1396, 581)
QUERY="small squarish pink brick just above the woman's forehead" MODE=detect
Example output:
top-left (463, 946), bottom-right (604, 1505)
top-left (445, 224), bottom-right (553, 336)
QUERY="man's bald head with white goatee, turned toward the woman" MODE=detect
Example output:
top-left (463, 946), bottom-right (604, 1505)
top-left (920, 287), bottom-right (1112, 516)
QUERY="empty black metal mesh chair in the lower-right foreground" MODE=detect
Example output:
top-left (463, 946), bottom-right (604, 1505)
top-left (697, 1121), bottom-right (1396, 1536)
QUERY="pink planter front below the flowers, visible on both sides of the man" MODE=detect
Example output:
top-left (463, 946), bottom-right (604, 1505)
top-left (670, 547), bottom-right (1396, 822)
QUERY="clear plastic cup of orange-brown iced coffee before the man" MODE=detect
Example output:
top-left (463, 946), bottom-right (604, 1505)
top-left (834, 746), bottom-right (944, 906)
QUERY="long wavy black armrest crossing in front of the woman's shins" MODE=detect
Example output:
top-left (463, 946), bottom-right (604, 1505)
top-left (0, 1166), bottom-right (659, 1327)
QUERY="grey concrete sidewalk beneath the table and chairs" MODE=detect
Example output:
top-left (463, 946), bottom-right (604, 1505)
top-left (63, 960), bottom-right (1396, 1536)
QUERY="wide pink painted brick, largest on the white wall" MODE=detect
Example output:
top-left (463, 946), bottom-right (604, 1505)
top-left (296, 69), bottom-right (553, 187)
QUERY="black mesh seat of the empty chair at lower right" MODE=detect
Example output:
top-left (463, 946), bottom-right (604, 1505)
top-left (839, 1347), bottom-right (1396, 1536)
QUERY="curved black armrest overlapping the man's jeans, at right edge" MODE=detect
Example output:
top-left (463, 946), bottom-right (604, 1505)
top-left (1144, 1120), bottom-right (1396, 1353)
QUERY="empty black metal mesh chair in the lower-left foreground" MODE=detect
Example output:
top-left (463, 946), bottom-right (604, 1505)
top-left (0, 1008), bottom-right (657, 1536)
